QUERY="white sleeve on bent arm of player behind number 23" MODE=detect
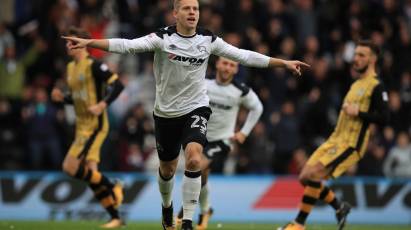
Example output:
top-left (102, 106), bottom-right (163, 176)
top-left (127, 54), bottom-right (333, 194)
top-left (241, 90), bottom-right (263, 136)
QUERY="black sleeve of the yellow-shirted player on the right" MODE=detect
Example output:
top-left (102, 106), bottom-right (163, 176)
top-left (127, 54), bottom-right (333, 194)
top-left (358, 84), bottom-right (390, 125)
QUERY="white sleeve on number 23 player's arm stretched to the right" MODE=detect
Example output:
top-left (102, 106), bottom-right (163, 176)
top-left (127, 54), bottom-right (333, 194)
top-left (211, 37), bottom-right (270, 68)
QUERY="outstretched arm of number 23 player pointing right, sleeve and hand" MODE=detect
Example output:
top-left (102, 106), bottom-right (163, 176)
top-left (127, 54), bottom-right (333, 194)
top-left (211, 37), bottom-right (310, 76)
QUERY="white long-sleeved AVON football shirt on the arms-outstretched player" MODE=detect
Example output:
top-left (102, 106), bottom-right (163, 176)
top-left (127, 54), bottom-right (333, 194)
top-left (109, 26), bottom-right (270, 118)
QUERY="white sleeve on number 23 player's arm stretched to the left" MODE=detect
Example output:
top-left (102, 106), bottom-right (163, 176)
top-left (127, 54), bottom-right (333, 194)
top-left (108, 33), bottom-right (163, 53)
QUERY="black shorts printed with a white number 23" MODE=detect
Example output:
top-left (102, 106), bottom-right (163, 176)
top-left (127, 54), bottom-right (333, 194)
top-left (153, 107), bottom-right (211, 161)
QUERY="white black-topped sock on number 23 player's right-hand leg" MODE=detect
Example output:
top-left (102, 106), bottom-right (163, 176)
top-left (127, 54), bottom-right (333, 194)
top-left (183, 170), bottom-right (201, 221)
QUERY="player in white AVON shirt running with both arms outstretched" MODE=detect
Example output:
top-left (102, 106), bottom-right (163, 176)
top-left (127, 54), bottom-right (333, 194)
top-left (63, 0), bottom-right (308, 230)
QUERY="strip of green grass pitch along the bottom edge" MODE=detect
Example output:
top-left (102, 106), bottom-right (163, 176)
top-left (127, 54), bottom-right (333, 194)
top-left (0, 221), bottom-right (411, 230)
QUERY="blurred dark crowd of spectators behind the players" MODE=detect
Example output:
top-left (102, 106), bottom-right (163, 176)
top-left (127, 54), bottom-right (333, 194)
top-left (0, 0), bottom-right (411, 177)
